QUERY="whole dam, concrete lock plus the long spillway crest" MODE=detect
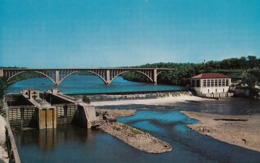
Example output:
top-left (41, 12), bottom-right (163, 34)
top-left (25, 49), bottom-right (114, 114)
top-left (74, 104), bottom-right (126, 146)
top-left (5, 89), bottom-right (192, 129)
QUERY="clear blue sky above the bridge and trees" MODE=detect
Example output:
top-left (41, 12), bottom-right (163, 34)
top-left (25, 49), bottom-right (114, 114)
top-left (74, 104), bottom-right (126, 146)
top-left (0, 0), bottom-right (260, 68)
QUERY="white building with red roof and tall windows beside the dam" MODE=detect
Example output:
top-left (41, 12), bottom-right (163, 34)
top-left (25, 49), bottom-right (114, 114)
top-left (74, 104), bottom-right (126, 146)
top-left (191, 73), bottom-right (231, 97)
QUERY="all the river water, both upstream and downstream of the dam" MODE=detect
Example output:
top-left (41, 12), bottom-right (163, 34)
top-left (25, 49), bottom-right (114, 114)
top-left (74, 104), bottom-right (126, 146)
top-left (6, 75), bottom-right (260, 163)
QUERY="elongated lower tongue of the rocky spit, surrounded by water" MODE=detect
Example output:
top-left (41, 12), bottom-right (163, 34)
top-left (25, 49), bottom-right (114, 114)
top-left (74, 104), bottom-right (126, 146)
top-left (100, 122), bottom-right (172, 153)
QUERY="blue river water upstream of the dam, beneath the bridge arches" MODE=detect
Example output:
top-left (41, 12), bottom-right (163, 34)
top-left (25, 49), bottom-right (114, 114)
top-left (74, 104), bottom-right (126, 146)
top-left (5, 74), bottom-right (187, 94)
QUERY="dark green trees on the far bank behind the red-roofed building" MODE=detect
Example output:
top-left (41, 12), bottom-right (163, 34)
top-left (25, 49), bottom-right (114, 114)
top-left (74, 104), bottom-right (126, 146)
top-left (122, 56), bottom-right (260, 86)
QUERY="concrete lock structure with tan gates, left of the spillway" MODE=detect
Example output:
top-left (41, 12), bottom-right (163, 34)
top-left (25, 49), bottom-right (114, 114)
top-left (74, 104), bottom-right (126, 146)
top-left (4, 89), bottom-right (100, 129)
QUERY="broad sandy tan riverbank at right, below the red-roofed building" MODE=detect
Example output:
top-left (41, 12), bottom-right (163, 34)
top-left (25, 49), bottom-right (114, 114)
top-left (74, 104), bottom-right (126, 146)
top-left (181, 111), bottom-right (260, 152)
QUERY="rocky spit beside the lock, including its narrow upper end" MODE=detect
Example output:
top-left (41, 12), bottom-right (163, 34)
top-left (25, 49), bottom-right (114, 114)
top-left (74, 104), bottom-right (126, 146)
top-left (96, 109), bottom-right (172, 153)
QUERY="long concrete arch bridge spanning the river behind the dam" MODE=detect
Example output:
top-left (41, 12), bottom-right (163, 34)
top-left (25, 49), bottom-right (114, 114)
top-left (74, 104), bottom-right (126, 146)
top-left (0, 68), bottom-right (173, 85)
